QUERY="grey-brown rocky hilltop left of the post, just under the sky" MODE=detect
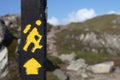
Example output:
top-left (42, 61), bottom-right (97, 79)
top-left (1, 14), bottom-right (21, 38)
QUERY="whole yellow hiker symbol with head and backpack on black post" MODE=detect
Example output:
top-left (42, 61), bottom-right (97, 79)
top-left (23, 20), bottom-right (43, 53)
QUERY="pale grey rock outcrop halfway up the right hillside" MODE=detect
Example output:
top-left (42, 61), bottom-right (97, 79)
top-left (79, 31), bottom-right (120, 55)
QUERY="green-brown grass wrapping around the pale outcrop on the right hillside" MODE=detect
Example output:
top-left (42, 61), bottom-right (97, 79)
top-left (56, 14), bottom-right (120, 63)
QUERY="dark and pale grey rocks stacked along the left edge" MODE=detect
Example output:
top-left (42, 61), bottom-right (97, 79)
top-left (0, 20), bottom-right (8, 79)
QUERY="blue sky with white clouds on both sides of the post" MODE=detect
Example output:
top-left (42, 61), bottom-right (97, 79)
top-left (0, 0), bottom-right (120, 25)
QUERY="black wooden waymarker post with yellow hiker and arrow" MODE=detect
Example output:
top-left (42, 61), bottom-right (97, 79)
top-left (18, 0), bottom-right (47, 80)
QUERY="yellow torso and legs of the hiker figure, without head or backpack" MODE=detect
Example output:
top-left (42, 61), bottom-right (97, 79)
top-left (23, 28), bottom-right (43, 53)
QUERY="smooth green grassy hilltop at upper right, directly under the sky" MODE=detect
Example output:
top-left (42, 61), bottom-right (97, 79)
top-left (68, 14), bottom-right (120, 34)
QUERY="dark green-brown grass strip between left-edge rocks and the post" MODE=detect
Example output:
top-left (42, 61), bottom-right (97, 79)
top-left (5, 39), bottom-right (20, 80)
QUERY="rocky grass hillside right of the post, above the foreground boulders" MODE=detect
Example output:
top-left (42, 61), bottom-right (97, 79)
top-left (48, 14), bottom-right (120, 63)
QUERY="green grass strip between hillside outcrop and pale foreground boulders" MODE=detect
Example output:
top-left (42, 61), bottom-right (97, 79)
top-left (76, 51), bottom-right (117, 64)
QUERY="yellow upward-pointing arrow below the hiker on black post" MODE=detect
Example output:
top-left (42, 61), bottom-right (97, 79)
top-left (23, 58), bottom-right (42, 75)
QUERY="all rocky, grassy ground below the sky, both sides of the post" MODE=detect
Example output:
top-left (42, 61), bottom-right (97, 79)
top-left (0, 14), bottom-right (120, 80)
